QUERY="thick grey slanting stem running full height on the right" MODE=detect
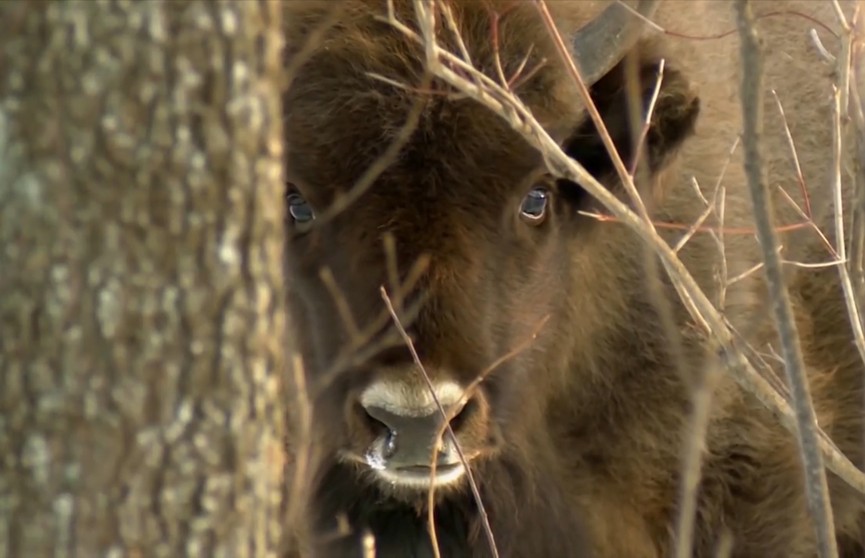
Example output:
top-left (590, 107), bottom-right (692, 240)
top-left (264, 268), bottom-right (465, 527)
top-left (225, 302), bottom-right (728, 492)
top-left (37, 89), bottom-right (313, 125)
top-left (736, 0), bottom-right (838, 558)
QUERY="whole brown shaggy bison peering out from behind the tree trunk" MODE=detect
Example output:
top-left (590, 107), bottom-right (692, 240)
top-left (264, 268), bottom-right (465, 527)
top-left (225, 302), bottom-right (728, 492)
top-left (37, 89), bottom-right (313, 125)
top-left (285, 0), bottom-right (865, 558)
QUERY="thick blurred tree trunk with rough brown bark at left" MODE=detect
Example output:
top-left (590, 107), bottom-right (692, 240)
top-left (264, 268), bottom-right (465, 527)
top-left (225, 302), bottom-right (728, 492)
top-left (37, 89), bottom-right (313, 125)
top-left (0, 0), bottom-right (285, 558)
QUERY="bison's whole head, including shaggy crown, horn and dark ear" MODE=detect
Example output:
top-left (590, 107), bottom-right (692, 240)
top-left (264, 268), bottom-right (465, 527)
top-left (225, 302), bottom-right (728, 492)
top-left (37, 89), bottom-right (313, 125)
top-left (285, 0), bottom-right (697, 508)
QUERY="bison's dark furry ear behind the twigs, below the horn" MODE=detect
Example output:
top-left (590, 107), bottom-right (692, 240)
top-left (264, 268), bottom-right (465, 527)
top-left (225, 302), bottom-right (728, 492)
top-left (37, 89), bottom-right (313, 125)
top-left (563, 46), bottom-right (700, 199)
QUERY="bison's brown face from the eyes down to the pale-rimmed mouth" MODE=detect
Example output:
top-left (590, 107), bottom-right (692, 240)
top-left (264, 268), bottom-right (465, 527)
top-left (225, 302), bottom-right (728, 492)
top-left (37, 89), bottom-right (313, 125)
top-left (288, 142), bottom-right (578, 495)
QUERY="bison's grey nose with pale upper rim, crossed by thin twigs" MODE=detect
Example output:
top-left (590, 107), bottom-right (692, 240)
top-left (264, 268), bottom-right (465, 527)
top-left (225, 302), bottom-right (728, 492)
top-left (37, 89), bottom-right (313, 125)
top-left (360, 384), bottom-right (486, 484)
